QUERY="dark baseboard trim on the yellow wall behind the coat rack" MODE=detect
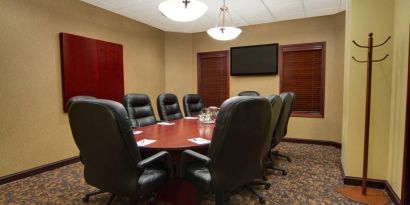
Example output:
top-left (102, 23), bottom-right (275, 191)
top-left (343, 176), bottom-right (401, 205)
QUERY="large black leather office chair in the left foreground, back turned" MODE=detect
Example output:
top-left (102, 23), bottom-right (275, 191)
top-left (68, 99), bottom-right (172, 204)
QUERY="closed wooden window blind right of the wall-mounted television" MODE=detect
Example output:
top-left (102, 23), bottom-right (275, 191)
top-left (280, 42), bottom-right (325, 117)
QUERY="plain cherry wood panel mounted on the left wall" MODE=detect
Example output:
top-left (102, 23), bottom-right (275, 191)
top-left (60, 33), bottom-right (124, 111)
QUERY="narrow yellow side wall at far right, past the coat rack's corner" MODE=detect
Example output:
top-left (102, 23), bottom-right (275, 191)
top-left (387, 0), bottom-right (410, 196)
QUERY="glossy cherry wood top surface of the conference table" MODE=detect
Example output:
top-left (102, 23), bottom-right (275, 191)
top-left (134, 119), bottom-right (214, 150)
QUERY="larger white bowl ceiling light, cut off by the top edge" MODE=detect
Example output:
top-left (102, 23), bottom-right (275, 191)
top-left (158, 0), bottom-right (208, 22)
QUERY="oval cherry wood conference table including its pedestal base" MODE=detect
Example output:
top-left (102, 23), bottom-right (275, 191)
top-left (133, 117), bottom-right (214, 205)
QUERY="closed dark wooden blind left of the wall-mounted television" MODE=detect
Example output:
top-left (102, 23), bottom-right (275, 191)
top-left (197, 51), bottom-right (229, 107)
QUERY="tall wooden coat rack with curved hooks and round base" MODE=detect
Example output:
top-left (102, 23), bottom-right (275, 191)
top-left (337, 33), bottom-right (391, 204)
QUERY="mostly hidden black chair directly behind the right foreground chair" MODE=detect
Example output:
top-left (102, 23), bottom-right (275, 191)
top-left (245, 95), bottom-right (282, 204)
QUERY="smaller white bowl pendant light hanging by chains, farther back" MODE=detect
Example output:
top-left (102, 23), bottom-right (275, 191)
top-left (206, 0), bottom-right (242, 41)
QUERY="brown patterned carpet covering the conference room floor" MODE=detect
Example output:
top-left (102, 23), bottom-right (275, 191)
top-left (0, 143), bottom-right (390, 205)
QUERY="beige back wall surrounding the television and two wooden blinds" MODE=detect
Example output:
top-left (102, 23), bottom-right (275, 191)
top-left (184, 13), bottom-right (345, 142)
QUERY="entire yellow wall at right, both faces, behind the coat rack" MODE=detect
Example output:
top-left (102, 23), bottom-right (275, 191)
top-left (342, 0), bottom-right (410, 196)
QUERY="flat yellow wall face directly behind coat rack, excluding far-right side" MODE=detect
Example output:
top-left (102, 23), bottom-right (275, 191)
top-left (342, 0), bottom-right (394, 179)
